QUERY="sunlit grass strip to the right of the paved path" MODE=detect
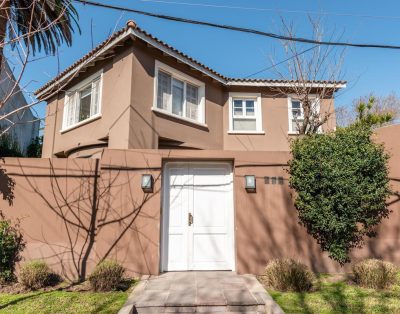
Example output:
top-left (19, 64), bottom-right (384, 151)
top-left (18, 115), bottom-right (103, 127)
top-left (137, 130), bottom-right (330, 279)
top-left (267, 278), bottom-right (400, 314)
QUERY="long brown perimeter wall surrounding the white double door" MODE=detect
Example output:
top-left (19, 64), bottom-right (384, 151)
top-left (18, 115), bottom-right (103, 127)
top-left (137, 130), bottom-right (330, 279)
top-left (0, 126), bottom-right (400, 279)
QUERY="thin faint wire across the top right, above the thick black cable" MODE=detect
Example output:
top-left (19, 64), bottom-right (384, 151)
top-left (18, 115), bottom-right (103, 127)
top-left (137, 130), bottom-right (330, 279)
top-left (139, 0), bottom-right (400, 20)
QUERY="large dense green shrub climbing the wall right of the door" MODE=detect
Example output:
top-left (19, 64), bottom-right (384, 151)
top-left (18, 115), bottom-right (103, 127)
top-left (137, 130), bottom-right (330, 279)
top-left (288, 123), bottom-right (390, 265)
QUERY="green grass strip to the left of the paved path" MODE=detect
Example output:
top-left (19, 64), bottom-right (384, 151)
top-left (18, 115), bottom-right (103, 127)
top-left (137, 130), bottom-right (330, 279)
top-left (0, 289), bottom-right (131, 314)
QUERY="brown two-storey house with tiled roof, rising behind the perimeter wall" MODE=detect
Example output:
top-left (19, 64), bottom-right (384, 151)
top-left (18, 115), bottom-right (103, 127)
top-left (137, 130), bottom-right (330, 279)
top-left (36, 21), bottom-right (345, 157)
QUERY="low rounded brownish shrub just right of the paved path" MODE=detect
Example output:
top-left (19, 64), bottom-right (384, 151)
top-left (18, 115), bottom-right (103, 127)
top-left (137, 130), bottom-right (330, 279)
top-left (264, 258), bottom-right (315, 292)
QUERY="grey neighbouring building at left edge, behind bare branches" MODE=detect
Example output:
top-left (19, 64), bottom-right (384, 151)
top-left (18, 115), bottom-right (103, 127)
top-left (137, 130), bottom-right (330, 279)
top-left (0, 61), bottom-right (40, 155)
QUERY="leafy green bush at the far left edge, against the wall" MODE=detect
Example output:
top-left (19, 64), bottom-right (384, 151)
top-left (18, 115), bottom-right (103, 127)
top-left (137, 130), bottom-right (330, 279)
top-left (0, 212), bottom-right (25, 284)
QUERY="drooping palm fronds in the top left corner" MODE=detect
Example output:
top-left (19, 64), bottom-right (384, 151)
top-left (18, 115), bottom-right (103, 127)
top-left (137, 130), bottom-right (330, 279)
top-left (0, 0), bottom-right (80, 68)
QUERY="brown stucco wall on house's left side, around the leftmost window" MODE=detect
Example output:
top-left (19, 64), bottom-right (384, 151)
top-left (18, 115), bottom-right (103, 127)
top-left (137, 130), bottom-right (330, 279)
top-left (42, 46), bottom-right (132, 158)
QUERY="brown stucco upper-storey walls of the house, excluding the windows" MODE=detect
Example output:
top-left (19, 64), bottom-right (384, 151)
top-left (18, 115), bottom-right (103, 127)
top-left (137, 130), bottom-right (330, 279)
top-left (39, 22), bottom-right (339, 158)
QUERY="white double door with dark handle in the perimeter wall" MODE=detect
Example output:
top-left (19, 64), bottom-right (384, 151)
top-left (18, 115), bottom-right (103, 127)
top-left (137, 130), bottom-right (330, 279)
top-left (161, 162), bottom-right (235, 271)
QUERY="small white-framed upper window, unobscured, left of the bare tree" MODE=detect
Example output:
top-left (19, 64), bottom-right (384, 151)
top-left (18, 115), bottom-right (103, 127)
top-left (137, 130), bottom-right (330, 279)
top-left (229, 93), bottom-right (263, 133)
